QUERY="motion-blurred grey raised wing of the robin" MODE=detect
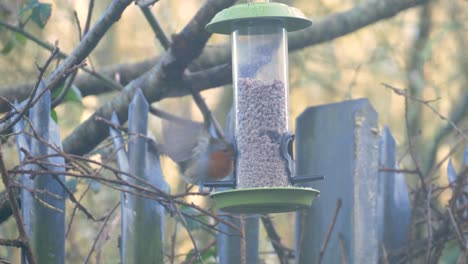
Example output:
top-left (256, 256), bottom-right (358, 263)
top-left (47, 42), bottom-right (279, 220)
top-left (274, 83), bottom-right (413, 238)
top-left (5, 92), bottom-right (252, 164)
top-left (162, 120), bottom-right (206, 162)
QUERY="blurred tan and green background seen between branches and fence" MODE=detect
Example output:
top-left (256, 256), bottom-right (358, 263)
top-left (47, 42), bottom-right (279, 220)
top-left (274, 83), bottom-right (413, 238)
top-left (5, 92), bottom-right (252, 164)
top-left (0, 0), bottom-right (468, 263)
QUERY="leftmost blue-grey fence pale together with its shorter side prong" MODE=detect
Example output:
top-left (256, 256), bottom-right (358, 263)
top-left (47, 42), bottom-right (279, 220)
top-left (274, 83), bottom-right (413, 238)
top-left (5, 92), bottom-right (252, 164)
top-left (14, 83), bottom-right (66, 263)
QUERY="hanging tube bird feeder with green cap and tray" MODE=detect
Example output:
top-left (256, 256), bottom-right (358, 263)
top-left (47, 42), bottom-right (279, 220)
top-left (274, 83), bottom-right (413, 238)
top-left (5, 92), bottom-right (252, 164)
top-left (206, 2), bottom-right (319, 213)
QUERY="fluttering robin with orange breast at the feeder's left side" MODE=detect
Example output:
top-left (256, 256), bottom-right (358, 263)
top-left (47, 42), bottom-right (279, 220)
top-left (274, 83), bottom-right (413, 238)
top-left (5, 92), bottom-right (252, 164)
top-left (162, 110), bottom-right (234, 184)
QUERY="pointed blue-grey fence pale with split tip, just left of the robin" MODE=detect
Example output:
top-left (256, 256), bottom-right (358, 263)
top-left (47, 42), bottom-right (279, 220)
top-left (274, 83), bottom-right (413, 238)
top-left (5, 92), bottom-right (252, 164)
top-left (110, 90), bottom-right (166, 263)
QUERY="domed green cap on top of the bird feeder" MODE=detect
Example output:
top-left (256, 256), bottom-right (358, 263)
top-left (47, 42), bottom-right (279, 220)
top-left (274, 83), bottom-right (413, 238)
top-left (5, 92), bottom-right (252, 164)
top-left (205, 2), bottom-right (312, 35)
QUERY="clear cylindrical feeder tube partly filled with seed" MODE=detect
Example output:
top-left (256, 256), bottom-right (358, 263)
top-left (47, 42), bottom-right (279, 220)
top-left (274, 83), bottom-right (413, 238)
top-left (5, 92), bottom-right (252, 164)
top-left (231, 19), bottom-right (288, 188)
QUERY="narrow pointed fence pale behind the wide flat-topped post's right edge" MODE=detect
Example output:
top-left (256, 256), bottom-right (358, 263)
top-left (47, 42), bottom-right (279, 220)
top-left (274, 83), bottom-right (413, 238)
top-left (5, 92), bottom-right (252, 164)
top-left (377, 127), bottom-right (411, 263)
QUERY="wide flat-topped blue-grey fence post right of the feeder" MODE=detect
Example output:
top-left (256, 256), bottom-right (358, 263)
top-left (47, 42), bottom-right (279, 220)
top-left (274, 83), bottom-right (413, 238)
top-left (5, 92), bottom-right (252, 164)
top-left (296, 99), bottom-right (379, 264)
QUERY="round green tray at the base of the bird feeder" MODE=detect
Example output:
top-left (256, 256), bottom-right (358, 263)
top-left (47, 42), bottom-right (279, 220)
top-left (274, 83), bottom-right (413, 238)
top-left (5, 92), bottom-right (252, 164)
top-left (210, 187), bottom-right (320, 214)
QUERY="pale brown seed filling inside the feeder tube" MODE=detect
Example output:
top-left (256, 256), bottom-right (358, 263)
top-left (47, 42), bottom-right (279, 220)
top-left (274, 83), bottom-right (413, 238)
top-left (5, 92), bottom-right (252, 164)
top-left (236, 78), bottom-right (288, 188)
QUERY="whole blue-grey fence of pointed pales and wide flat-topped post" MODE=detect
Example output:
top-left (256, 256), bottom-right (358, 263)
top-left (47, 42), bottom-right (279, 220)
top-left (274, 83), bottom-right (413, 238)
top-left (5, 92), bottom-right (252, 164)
top-left (14, 91), bottom-right (410, 264)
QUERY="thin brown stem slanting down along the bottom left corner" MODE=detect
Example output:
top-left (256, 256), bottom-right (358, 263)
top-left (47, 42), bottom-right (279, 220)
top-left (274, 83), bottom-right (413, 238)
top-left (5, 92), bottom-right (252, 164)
top-left (0, 144), bottom-right (36, 264)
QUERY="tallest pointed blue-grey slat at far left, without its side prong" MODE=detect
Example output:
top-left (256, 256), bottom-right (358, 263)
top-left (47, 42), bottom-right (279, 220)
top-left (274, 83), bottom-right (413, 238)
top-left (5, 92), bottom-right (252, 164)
top-left (26, 83), bottom-right (66, 263)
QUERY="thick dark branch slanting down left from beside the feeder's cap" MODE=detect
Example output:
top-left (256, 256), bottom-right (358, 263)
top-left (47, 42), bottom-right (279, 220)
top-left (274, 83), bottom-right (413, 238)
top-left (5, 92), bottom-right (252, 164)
top-left (64, 0), bottom-right (234, 154)
